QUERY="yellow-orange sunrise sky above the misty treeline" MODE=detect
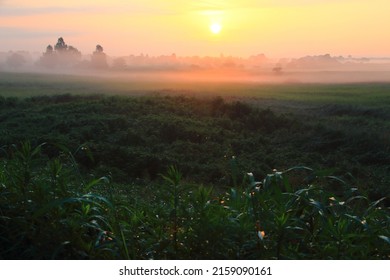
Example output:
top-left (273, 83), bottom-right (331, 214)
top-left (0, 0), bottom-right (390, 58)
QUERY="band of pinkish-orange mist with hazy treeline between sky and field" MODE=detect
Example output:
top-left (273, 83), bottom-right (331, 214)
top-left (0, 37), bottom-right (390, 83)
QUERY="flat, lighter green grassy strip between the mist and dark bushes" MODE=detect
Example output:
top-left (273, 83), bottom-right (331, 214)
top-left (0, 72), bottom-right (390, 108)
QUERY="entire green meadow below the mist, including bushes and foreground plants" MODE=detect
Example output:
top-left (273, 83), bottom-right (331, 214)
top-left (0, 73), bottom-right (390, 259)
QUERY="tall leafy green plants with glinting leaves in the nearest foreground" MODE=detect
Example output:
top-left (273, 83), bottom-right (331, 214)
top-left (0, 142), bottom-right (390, 259)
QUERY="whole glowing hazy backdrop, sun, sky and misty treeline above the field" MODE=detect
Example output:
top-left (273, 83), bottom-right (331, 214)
top-left (0, 0), bottom-right (390, 83)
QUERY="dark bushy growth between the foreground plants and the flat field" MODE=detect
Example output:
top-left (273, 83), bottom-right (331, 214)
top-left (0, 94), bottom-right (390, 197)
